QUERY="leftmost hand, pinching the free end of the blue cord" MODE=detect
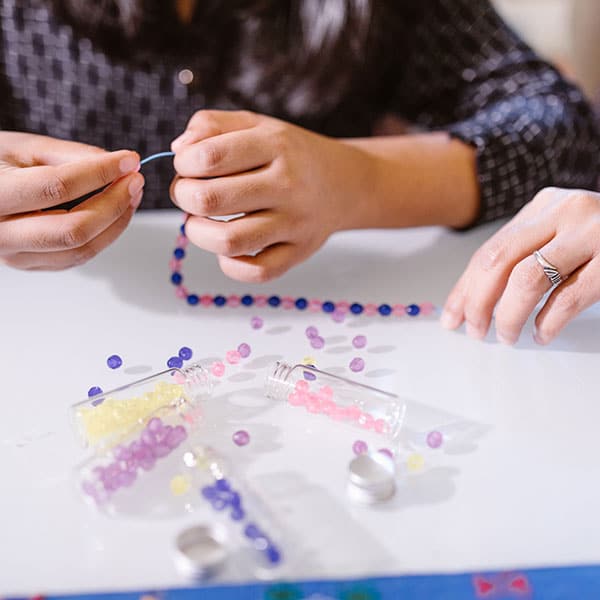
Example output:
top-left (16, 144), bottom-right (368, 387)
top-left (0, 132), bottom-right (144, 270)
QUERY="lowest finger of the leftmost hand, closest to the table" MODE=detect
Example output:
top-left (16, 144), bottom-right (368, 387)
top-left (2, 206), bottom-right (135, 271)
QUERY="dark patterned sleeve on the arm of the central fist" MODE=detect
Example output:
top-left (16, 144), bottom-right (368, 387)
top-left (395, 0), bottom-right (600, 225)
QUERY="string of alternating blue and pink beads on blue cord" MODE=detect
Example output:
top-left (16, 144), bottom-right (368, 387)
top-left (140, 152), bottom-right (435, 317)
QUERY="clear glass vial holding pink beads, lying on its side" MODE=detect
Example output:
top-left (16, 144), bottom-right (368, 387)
top-left (265, 362), bottom-right (406, 445)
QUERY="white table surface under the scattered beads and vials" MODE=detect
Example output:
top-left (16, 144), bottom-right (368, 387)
top-left (0, 212), bottom-right (600, 595)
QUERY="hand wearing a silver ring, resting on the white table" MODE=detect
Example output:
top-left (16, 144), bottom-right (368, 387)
top-left (442, 188), bottom-right (600, 344)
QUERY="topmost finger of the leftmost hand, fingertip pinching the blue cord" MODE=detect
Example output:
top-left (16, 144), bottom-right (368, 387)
top-left (0, 150), bottom-right (139, 215)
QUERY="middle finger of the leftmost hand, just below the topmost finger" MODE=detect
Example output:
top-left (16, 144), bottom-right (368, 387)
top-left (0, 173), bottom-right (144, 254)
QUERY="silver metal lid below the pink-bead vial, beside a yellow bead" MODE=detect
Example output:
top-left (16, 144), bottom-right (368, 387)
top-left (347, 452), bottom-right (396, 504)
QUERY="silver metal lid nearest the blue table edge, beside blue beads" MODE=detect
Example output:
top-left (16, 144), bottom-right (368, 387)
top-left (175, 524), bottom-right (229, 579)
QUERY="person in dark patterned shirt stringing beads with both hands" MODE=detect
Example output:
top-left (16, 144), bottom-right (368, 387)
top-left (0, 0), bottom-right (599, 281)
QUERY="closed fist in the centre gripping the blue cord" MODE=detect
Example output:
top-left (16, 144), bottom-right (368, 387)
top-left (171, 111), bottom-right (371, 282)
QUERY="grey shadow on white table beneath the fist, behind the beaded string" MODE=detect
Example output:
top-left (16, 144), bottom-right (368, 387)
top-left (81, 221), bottom-right (493, 313)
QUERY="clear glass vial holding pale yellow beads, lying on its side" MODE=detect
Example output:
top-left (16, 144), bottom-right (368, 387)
top-left (71, 363), bottom-right (213, 449)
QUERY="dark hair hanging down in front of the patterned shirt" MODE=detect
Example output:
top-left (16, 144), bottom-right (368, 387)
top-left (51, 0), bottom-right (398, 116)
